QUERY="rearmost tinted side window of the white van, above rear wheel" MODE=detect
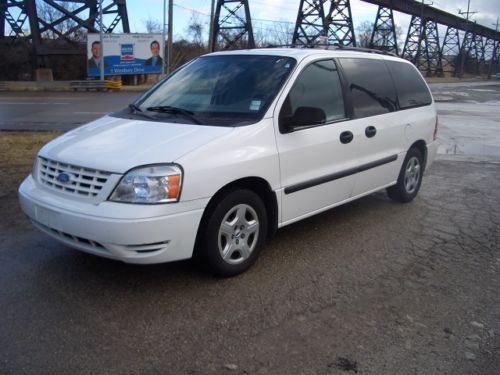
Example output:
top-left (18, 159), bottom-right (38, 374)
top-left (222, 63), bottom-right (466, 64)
top-left (386, 61), bottom-right (432, 109)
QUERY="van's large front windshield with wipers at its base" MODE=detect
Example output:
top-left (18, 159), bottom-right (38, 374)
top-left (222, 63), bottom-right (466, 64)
top-left (135, 55), bottom-right (296, 126)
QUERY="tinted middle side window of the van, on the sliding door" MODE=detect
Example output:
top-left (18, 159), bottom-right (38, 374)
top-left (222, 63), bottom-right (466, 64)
top-left (339, 58), bottom-right (396, 118)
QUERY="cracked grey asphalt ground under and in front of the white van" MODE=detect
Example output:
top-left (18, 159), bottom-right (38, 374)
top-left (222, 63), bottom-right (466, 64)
top-left (0, 81), bottom-right (500, 375)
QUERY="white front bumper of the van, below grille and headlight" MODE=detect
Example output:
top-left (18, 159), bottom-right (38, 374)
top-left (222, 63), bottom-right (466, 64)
top-left (19, 176), bottom-right (208, 264)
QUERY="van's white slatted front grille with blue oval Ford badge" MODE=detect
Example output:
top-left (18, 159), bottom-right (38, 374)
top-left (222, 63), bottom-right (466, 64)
top-left (38, 157), bottom-right (111, 198)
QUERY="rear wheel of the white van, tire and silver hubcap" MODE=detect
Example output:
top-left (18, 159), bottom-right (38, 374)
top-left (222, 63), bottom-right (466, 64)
top-left (387, 148), bottom-right (424, 203)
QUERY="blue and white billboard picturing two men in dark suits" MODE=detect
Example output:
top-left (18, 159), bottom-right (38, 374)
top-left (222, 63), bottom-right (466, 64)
top-left (87, 34), bottom-right (163, 77)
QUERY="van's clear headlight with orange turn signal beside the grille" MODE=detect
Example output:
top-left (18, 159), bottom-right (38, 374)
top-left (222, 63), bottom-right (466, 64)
top-left (109, 164), bottom-right (182, 204)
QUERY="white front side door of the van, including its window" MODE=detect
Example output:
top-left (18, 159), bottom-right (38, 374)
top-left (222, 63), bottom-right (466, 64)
top-left (274, 60), bottom-right (359, 225)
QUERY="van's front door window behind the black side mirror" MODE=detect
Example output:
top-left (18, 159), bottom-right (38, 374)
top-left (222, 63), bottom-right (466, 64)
top-left (279, 60), bottom-right (345, 132)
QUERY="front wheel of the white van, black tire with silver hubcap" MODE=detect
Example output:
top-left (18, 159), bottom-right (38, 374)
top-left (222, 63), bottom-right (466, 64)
top-left (199, 190), bottom-right (267, 277)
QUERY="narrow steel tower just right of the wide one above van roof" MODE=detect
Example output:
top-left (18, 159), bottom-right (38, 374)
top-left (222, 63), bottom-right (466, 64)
top-left (369, 6), bottom-right (399, 55)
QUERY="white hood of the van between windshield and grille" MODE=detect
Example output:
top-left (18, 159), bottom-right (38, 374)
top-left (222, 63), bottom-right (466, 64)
top-left (40, 116), bottom-right (234, 173)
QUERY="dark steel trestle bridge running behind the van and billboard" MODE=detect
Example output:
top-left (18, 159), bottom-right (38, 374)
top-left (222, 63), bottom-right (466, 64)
top-left (0, 0), bottom-right (500, 76)
